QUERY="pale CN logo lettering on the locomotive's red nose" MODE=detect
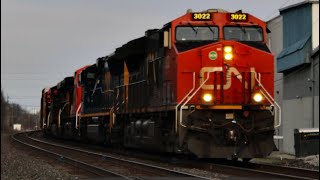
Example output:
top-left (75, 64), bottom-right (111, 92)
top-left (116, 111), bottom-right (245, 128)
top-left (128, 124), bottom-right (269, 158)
top-left (200, 67), bottom-right (255, 90)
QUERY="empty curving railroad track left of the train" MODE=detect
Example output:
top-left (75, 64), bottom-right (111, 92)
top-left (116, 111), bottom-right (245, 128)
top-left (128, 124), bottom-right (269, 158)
top-left (12, 133), bottom-right (210, 179)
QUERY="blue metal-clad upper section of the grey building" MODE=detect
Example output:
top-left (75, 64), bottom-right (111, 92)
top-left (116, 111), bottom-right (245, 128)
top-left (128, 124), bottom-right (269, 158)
top-left (277, 3), bottom-right (312, 72)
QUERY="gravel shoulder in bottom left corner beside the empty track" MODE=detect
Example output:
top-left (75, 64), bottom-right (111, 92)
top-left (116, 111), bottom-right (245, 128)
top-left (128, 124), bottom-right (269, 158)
top-left (1, 132), bottom-right (81, 180)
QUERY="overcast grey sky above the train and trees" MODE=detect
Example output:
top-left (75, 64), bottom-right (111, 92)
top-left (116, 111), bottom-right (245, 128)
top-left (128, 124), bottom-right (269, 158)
top-left (1, 0), bottom-right (301, 111)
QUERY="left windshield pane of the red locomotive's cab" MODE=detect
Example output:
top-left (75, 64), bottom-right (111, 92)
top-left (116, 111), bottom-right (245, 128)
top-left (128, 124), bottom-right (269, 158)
top-left (176, 26), bottom-right (219, 41)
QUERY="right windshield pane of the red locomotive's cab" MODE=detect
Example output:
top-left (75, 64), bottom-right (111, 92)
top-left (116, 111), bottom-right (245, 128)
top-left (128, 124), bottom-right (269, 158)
top-left (223, 26), bottom-right (263, 42)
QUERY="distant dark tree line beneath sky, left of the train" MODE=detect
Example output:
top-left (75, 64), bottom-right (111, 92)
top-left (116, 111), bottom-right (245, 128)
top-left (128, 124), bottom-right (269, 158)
top-left (1, 89), bottom-right (39, 131)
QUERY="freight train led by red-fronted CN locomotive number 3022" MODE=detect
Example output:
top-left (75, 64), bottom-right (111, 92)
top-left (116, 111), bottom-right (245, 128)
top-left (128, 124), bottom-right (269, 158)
top-left (41, 9), bottom-right (280, 159)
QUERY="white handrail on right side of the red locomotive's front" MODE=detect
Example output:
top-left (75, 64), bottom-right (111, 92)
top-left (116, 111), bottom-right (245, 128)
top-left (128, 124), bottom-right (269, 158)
top-left (253, 71), bottom-right (281, 128)
